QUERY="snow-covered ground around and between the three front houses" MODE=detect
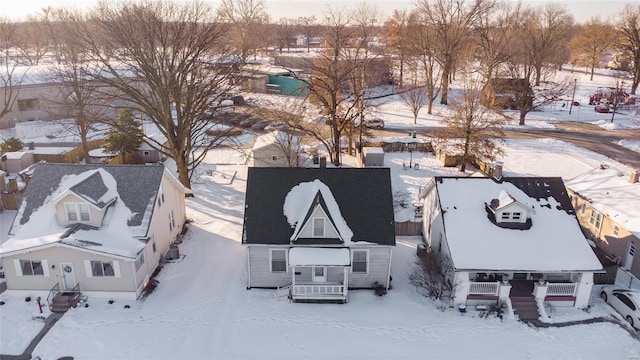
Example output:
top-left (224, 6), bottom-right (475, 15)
top-left (0, 140), bottom-right (640, 359)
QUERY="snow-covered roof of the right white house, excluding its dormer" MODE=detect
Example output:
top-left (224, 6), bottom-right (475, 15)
top-left (436, 177), bottom-right (602, 272)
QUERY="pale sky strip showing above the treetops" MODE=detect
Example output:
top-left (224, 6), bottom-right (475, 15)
top-left (0, 0), bottom-right (633, 23)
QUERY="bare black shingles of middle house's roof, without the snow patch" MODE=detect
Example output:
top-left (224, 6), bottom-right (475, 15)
top-left (242, 168), bottom-right (395, 245)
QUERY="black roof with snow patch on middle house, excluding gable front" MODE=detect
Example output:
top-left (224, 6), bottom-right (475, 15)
top-left (242, 167), bottom-right (395, 246)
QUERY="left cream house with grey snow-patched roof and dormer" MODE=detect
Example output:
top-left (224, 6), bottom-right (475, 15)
top-left (0, 163), bottom-right (190, 303)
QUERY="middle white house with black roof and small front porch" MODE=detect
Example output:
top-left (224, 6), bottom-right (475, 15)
top-left (242, 167), bottom-right (395, 302)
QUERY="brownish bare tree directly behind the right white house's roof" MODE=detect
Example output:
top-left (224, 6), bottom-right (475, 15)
top-left (433, 78), bottom-right (505, 172)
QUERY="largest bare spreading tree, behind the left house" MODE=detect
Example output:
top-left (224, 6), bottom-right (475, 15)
top-left (84, 1), bottom-right (238, 188)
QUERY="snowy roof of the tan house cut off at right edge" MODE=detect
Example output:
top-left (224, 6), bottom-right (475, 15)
top-left (567, 167), bottom-right (640, 238)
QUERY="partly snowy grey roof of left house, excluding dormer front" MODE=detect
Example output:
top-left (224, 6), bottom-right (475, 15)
top-left (0, 163), bottom-right (184, 258)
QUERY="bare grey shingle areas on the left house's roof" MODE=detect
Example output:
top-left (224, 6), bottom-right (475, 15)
top-left (16, 163), bottom-right (164, 226)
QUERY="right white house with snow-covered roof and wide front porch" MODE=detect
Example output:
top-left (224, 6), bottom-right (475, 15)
top-left (420, 177), bottom-right (602, 318)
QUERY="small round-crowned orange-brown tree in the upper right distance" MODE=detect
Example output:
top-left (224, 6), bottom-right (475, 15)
top-left (571, 18), bottom-right (615, 81)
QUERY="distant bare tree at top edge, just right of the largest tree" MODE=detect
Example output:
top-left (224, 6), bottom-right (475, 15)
top-left (218, 0), bottom-right (269, 61)
